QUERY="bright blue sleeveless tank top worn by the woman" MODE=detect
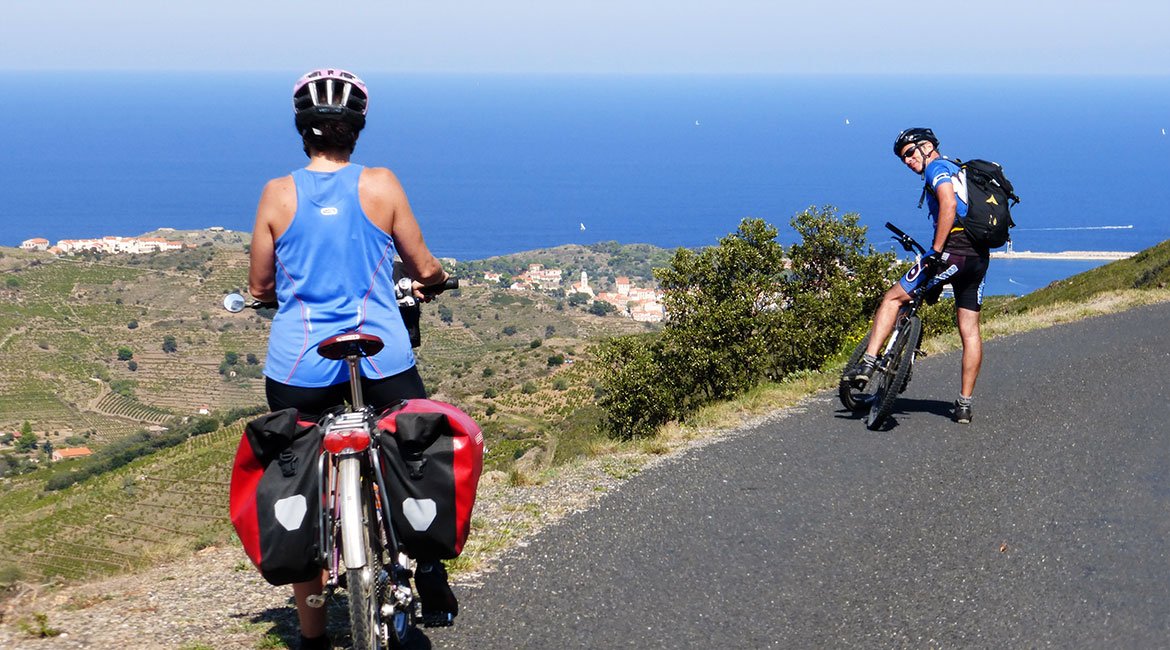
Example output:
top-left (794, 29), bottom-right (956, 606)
top-left (264, 164), bottom-right (414, 387)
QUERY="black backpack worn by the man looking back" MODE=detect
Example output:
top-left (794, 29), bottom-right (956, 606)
top-left (955, 159), bottom-right (1020, 248)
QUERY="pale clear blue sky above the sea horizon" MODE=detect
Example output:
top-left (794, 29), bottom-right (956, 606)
top-left (0, 0), bottom-right (1170, 75)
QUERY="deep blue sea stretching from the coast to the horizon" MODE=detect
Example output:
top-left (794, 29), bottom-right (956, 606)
top-left (0, 71), bottom-right (1170, 295)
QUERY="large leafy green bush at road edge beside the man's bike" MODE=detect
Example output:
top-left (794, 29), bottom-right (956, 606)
top-left (597, 207), bottom-right (899, 437)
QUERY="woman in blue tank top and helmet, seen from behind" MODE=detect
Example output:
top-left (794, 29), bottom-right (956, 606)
top-left (248, 69), bottom-right (459, 648)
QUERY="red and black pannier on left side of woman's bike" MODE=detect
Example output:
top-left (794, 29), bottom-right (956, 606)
top-left (230, 408), bottom-right (324, 585)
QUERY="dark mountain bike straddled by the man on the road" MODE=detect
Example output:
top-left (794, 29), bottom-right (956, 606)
top-left (837, 223), bottom-right (936, 429)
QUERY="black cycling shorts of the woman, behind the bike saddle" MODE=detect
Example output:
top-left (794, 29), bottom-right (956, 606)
top-left (264, 366), bottom-right (427, 421)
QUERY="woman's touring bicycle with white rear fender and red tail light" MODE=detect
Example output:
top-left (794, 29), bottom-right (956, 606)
top-left (223, 278), bottom-right (459, 650)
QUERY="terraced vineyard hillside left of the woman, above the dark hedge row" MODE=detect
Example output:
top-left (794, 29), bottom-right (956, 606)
top-left (0, 240), bottom-right (266, 444)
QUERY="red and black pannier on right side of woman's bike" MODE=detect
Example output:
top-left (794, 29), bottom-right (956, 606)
top-left (377, 400), bottom-right (483, 560)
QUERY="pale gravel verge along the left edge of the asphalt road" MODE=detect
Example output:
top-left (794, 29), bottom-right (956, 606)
top-left (0, 418), bottom-right (758, 650)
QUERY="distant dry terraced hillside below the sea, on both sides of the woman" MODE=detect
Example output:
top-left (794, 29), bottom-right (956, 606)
top-left (0, 231), bottom-right (664, 455)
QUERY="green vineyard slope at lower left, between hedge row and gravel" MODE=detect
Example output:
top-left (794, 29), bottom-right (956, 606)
top-left (0, 423), bottom-right (242, 579)
